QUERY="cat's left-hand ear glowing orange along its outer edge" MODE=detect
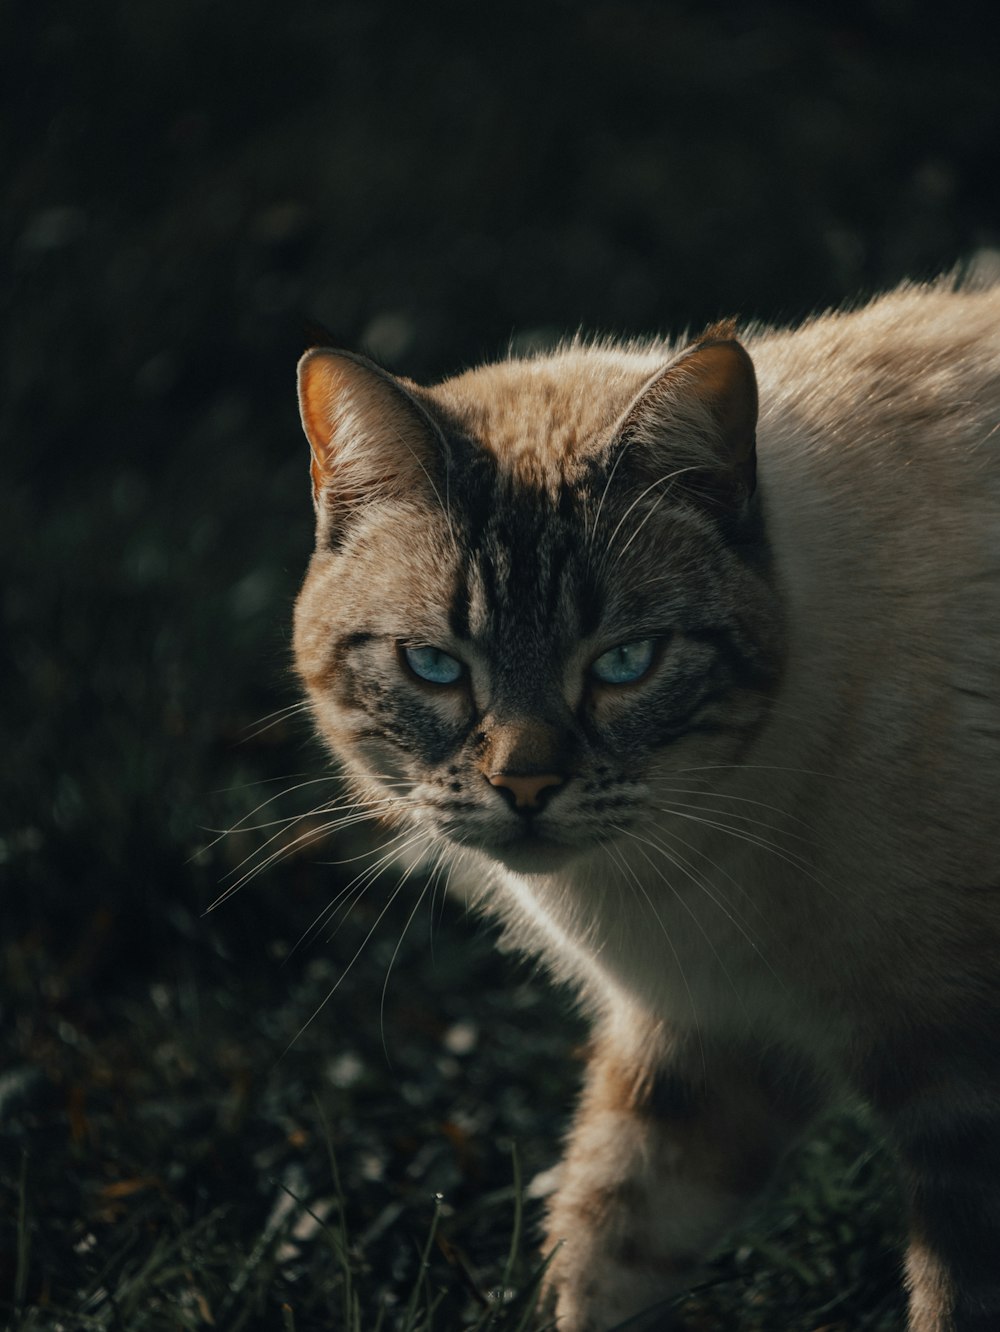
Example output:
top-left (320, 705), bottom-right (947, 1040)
top-left (298, 348), bottom-right (437, 531)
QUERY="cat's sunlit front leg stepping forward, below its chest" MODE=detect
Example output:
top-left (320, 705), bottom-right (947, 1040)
top-left (545, 1030), bottom-right (819, 1332)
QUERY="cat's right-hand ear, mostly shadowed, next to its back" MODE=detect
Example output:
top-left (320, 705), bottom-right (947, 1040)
top-left (619, 321), bottom-right (758, 515)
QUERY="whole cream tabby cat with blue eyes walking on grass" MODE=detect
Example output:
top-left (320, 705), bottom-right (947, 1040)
top-left (288, 280), bottom-right (1000, 1332)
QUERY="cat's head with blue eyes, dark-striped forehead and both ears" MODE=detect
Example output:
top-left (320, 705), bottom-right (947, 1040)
top-left (294, 325), bottom-right (782, 872)
